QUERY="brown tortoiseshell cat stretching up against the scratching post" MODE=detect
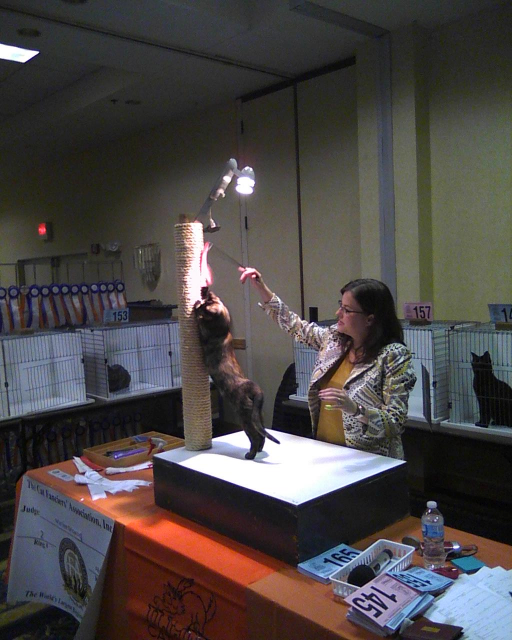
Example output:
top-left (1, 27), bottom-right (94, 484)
top-left (194, 291), bottom-right (280, 460)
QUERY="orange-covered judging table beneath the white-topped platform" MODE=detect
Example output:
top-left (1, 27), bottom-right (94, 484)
top-left (7, 461), bottom-right (512, 640)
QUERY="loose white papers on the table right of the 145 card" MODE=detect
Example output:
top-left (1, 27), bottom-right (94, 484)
top-left (428, 567), bottom-right (512, 640)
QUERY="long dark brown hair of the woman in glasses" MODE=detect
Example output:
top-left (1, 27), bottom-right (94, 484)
top-left (341, 278), bottom-right (404, 362)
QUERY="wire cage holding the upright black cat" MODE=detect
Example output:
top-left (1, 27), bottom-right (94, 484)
top-left (449, 323), bottom-right (512, 431)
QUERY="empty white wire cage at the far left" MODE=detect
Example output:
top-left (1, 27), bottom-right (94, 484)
top-left (0, 332), bottom-right (87, 419)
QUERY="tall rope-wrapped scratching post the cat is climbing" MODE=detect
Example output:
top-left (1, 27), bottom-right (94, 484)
top-left (174, 222), bottom-right (212, 451)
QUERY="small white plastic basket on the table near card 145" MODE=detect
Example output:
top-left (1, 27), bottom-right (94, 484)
top-left (330, 538), bottom-right (415, 598)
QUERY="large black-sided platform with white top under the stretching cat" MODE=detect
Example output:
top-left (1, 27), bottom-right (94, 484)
top-left (153, 431), bottom-right (409, 565)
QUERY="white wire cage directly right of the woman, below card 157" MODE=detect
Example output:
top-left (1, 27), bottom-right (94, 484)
top-left (402, 320), bottom-right (474, 421)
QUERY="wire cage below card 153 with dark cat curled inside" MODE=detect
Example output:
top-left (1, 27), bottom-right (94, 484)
top-left (78, 321), bottom-right (181, 400)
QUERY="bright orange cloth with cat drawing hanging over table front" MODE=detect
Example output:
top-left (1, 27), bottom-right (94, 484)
top-left (124, 511), bottom-right (285, 640)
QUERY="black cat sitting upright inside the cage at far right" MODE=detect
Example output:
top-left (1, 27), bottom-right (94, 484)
top-left (471, 351), bottom-right (512, 427)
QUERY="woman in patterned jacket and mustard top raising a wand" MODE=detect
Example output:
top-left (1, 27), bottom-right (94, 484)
top-left (240, 267), bottom-right (416, 460)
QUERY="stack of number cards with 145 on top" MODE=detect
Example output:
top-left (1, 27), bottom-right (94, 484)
top-left (345, 573), bottom-right (434, 636)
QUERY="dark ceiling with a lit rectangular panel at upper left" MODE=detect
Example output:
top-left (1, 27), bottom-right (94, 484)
top-left (0, 0), bottom-right (505, 169)
